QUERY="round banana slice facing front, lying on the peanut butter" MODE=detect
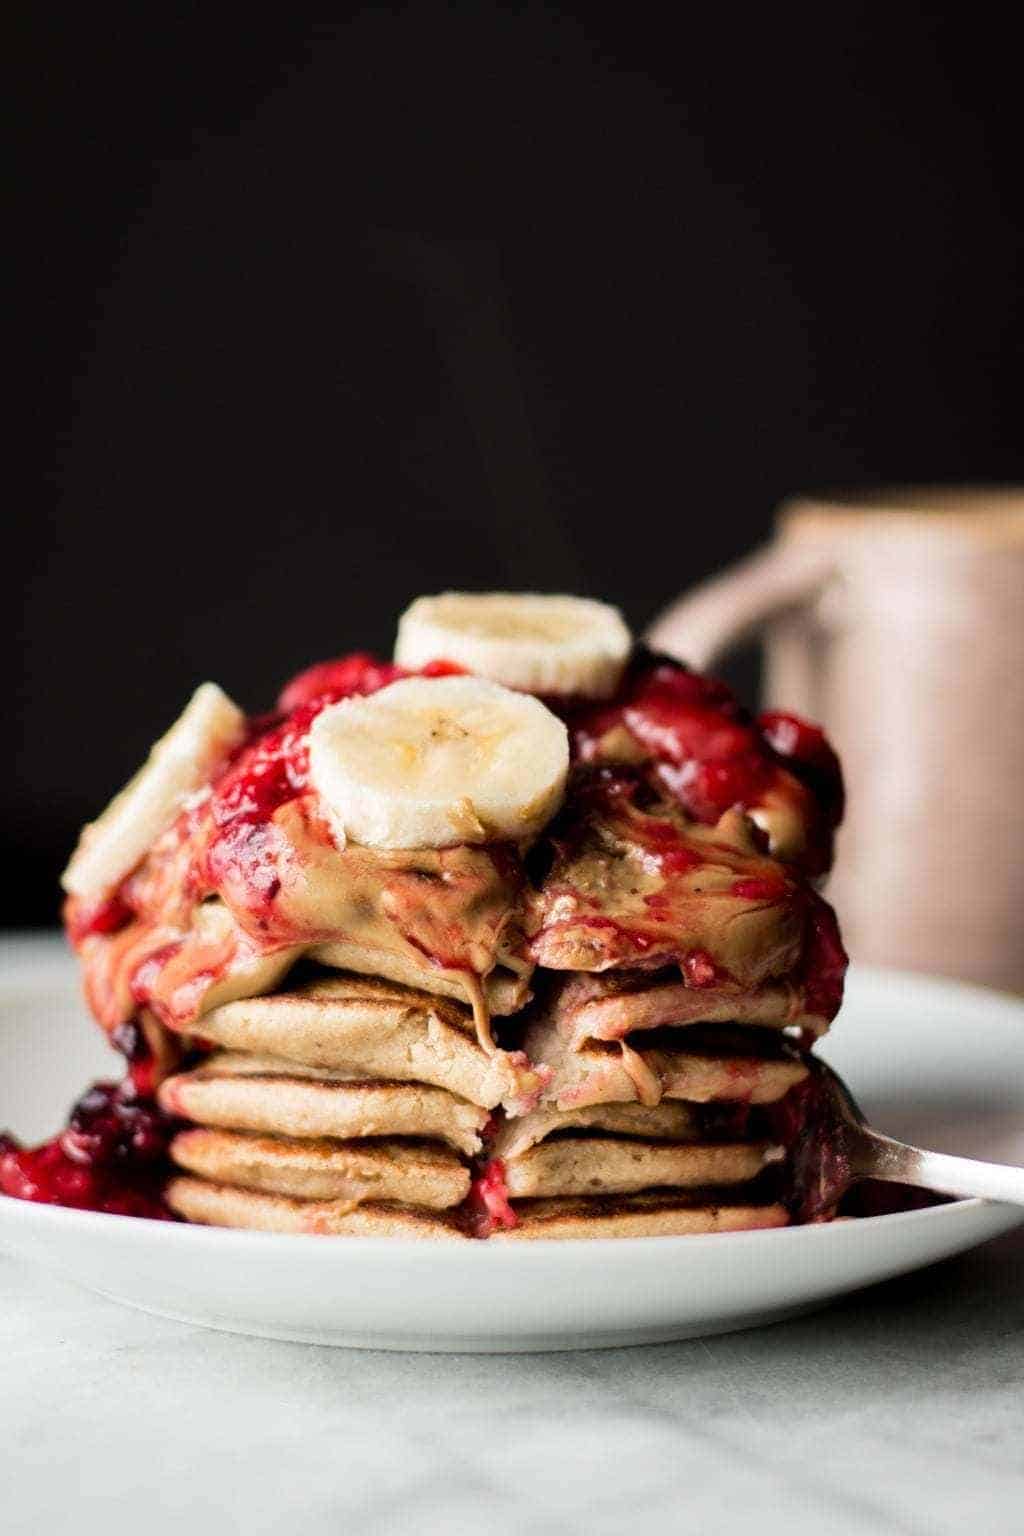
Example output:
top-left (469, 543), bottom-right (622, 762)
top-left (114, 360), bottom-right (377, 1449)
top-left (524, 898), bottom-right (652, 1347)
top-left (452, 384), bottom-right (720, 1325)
top-left (309, 677), bottom-right (570, 848)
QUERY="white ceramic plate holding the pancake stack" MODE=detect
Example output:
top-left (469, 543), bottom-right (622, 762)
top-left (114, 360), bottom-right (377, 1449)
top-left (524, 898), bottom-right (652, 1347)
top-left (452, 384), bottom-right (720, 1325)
top-left (0, 938), bottom-right (1024, 1352)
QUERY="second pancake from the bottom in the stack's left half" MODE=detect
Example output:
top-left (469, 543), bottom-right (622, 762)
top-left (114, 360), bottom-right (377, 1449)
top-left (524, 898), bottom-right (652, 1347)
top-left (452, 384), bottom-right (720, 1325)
top-left (170, 1127), bottom-right (470, 1210)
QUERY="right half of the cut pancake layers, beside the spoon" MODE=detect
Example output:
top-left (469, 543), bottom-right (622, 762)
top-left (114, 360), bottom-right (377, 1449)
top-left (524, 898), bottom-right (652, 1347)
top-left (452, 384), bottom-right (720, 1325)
top-left (484, 975), bottom-right (809, 1238)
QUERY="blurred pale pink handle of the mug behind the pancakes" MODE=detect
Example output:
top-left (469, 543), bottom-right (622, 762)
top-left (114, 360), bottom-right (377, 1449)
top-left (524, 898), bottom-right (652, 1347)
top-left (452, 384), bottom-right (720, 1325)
top-left (645, 541), bottom-right (835, 671)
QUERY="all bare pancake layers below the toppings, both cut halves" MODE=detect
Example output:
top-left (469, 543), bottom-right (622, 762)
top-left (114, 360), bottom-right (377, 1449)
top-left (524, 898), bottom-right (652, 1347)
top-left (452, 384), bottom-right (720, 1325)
top-left (160, 972), bottom-right (808, 1240)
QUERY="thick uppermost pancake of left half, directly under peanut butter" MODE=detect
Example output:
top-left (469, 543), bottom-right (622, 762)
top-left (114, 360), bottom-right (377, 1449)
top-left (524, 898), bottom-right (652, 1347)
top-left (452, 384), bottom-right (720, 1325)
top-left (191, 975), bottom-right (543, 1114)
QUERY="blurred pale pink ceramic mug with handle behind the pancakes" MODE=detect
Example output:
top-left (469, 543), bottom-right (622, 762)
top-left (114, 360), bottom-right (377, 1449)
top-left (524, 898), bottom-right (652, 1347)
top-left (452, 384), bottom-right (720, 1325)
top-left (648, 488), bottom-right (1024, 989)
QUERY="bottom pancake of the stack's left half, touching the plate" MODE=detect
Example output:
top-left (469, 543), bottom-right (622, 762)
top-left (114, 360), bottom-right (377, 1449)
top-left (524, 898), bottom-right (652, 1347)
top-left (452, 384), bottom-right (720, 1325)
top-left (164, 1175), bottom-right (465, 1241)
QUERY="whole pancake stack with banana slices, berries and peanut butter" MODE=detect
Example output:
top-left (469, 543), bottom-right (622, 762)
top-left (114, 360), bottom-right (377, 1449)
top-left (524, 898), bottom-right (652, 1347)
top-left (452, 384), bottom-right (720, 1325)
top-left (52, 593), bottom-right (846, 1240)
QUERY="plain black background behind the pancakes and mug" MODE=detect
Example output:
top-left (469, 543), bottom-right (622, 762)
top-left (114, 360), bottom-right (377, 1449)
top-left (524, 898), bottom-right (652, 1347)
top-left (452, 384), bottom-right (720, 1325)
top-left (10, 5), bottom-right (1024, 925)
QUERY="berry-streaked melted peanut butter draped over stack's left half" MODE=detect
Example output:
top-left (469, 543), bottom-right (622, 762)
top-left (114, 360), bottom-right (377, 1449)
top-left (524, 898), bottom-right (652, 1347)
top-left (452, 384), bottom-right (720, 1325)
top-left (69, 780), bottom-right (533, 1055)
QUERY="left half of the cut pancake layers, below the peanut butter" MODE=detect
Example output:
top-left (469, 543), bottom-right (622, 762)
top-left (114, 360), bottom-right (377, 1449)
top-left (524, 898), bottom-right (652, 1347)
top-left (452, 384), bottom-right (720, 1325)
top-left (160, 974), bottom-right (543, 1238)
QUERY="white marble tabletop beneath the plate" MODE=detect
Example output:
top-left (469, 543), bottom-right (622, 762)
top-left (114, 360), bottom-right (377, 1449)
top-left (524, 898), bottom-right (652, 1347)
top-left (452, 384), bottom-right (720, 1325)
top-left (0, 1230), bottom-right (1024, 1536)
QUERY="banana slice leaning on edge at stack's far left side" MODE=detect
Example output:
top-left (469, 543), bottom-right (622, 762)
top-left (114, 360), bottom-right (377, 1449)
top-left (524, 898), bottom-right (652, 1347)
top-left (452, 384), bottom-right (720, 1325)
top-left (61, 682), bottom-right (246, 902)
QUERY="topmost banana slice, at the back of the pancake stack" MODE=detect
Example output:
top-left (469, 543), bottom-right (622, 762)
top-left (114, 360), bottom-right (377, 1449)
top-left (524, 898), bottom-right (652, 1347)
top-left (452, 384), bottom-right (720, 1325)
top-left (395, 591), bottom-right (633, 699)
